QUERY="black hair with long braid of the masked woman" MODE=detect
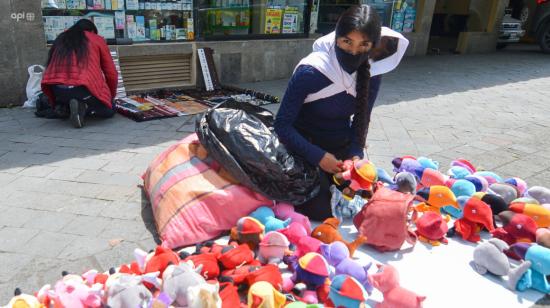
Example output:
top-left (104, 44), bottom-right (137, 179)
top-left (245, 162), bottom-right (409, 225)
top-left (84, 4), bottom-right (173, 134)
top-left (335, 5), bottom-right (382, 148)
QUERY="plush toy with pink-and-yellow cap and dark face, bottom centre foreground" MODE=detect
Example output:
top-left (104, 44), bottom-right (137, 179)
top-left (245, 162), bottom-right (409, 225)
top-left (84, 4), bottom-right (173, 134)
top-left (283, 252), bottom-right (329, 304)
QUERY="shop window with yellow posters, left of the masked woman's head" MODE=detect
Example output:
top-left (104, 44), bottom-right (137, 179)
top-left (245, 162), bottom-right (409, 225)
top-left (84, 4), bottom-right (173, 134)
top-left (199, 0), bottom-right (306, 39)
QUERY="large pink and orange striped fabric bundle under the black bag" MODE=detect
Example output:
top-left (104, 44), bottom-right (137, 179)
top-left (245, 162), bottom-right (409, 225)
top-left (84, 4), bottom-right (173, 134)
top-left (143, 134), bottom-right (271, 248)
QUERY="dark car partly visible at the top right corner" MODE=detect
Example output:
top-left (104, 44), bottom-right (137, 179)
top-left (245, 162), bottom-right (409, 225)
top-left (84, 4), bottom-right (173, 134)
top-left (509, 0), bottom-right (550, 53)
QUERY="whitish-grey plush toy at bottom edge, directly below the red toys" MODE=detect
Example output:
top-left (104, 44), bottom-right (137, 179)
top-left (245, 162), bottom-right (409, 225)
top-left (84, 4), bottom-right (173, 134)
top-left (162, 262), bottom-right (221, 307)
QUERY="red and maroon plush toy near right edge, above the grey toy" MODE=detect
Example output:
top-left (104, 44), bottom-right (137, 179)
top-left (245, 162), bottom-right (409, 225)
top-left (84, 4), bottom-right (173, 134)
top-left (491, 211), bottom-right (537, 245)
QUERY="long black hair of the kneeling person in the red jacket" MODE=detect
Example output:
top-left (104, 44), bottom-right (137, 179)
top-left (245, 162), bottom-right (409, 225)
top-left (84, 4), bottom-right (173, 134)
top-left (46, 19), bottom-right (97, 66)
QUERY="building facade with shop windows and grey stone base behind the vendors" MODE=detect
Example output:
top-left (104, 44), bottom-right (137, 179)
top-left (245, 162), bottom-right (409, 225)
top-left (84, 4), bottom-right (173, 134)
top-left (0, 0), bottom-right (506, 106)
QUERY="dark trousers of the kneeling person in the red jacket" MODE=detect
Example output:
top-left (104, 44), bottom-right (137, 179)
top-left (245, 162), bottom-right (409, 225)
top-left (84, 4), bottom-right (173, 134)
top-left (52, 86), bottom-right (115, 118)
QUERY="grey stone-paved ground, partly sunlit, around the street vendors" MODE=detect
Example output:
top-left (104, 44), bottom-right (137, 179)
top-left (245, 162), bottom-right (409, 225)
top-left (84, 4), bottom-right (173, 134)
top-left (0, 44), bottom-right (550, 304)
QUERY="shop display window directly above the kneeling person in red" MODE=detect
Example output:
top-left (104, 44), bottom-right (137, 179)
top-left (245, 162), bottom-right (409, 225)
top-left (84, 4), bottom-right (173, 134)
top-left (42, 0), bottom-right (195, 43)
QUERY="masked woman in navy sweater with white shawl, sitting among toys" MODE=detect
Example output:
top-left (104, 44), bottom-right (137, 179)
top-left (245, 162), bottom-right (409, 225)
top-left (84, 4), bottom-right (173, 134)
top-left (275, 5), bottom-right (409, 220)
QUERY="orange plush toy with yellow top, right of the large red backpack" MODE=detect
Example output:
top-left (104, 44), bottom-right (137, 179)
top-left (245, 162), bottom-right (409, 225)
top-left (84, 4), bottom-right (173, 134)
top-left (415, 185), bottom-right (460, 213)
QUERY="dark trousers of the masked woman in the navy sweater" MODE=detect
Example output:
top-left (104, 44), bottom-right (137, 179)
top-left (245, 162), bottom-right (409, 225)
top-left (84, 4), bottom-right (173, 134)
top-left (296, 137), bottom-right (351, 221)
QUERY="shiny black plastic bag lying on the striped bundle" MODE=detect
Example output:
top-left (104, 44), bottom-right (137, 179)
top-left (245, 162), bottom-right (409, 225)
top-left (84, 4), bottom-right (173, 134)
top-left (196, 100), bottom-right (320, 205)
